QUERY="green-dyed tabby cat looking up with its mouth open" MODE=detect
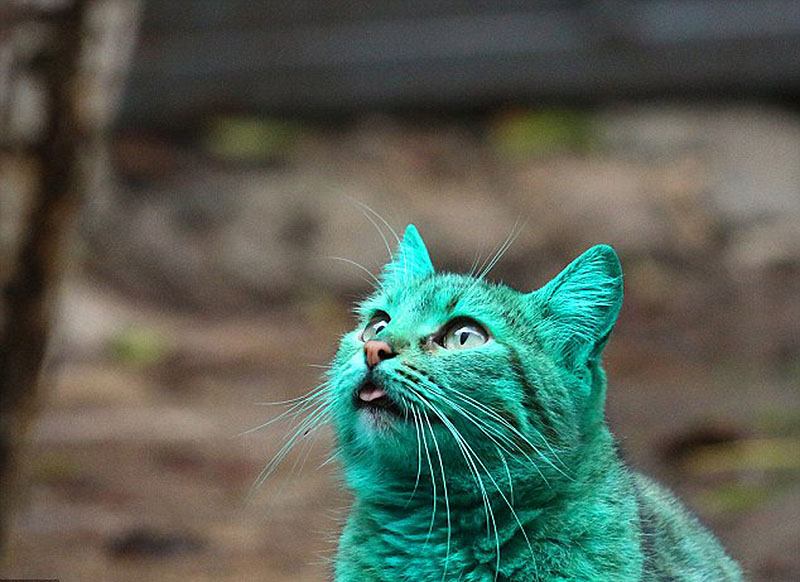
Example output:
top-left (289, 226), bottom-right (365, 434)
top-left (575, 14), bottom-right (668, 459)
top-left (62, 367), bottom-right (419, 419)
top-left (318, 225), bottom-right (742, 582)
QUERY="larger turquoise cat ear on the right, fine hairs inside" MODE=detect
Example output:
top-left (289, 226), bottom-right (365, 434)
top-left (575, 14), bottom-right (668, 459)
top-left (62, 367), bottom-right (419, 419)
top-left (529, 245), bottom-right (622, 367)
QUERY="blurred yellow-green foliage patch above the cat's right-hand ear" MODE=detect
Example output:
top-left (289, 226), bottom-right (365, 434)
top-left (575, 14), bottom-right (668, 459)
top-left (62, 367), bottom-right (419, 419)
top-left (488, 109), bottom-right (597, 160)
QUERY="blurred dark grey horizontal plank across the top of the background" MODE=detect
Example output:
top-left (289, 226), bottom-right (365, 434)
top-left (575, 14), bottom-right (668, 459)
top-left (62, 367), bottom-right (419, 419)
top-left (117, 0), bottom-right (800, 123)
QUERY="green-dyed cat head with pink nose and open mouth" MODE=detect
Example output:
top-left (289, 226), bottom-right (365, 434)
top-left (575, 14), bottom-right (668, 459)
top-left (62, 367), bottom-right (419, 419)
top-left (329, 225), bottom-right (622, 500)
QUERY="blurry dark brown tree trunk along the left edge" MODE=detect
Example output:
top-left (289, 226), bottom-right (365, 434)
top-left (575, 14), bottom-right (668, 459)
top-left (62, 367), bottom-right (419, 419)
top-left (0, 0), bottom-right (137, 552)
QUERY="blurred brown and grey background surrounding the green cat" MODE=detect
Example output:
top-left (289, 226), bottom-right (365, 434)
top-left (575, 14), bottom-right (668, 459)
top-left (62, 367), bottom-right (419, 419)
top-left (0, 0), bottom-right (800, 582)
